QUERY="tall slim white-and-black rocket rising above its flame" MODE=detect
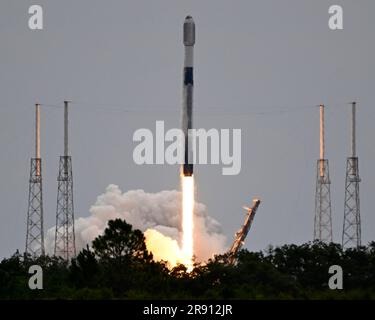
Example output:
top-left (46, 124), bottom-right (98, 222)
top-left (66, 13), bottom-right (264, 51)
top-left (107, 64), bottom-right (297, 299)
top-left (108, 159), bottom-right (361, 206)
top-left (182, 16), bottom-right (195, 176)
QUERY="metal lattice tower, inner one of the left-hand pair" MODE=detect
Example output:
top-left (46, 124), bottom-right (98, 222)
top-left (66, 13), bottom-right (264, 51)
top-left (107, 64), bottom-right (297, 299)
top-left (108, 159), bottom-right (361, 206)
top-left (54, 101), bottom-right (76, 261)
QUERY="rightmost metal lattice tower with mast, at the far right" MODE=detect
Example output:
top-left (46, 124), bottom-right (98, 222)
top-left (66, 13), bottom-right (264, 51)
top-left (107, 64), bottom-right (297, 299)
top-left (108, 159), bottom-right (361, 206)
top-left (342, 102), bottom-right (361, 248)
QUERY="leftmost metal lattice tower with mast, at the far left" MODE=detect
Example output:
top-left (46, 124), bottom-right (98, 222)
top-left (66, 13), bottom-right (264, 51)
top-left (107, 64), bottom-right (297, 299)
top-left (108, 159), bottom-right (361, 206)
top-left (25, 104), bottom-right (44, 256)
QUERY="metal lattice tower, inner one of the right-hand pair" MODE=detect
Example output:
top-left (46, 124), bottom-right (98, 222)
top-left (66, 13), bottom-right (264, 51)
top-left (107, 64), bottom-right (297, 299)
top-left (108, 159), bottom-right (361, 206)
top-left (314, 105), bottom-right (332, 242)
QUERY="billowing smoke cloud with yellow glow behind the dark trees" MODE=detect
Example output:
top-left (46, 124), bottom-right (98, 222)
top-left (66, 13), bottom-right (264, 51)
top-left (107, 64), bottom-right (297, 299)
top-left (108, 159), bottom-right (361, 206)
top-left (46, 184), bottom-right (226, 266)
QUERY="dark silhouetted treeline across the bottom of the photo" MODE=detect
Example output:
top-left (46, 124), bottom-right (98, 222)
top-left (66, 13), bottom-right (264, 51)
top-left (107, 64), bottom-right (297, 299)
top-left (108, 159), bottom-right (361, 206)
top-left (0, 219), bottom-right (375, 299)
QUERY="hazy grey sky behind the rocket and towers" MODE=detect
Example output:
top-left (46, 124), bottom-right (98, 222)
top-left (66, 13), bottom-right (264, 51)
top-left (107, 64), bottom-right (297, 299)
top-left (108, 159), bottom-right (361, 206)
top-left (0, 0), bottom-right (375, 257)
